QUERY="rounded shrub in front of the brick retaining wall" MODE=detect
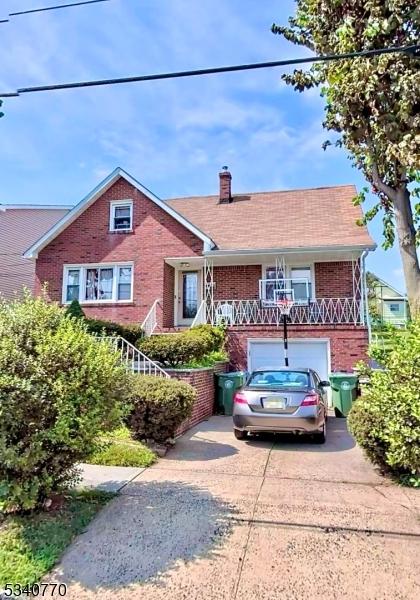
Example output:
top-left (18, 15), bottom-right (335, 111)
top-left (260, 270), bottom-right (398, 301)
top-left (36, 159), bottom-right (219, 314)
top-left (128, 375), bottom-right (196, 443)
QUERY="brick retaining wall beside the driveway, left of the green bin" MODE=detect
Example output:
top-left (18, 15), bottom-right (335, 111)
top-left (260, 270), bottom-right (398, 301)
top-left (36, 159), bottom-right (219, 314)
top-left (168, 363), bottom-right (227, 435)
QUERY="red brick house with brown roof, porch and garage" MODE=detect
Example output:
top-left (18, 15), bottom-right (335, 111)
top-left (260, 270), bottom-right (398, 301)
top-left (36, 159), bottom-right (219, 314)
top-left (25, 169), bottom-right (375, 379)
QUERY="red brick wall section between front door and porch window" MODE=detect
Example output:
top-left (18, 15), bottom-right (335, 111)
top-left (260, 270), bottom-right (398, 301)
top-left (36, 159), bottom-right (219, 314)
top-left (213, 265), bottom-right (262, 300)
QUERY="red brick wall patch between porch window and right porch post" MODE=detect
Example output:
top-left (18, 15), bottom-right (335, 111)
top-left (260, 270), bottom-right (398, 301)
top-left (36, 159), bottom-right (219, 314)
top-left (315, 261), bottom-right (353, 298)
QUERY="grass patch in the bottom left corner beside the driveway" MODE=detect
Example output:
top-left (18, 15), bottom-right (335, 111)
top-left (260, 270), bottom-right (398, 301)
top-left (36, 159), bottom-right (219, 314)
top-left (0, 491), bottom-right (113, 589)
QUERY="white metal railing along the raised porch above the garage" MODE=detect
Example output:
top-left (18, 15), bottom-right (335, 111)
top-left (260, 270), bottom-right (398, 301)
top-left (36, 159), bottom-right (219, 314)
top-left (212, 298), bottom-right (364, 326)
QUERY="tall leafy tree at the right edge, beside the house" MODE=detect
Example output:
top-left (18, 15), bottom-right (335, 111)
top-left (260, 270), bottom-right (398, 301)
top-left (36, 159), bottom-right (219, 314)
top-left (272, 0), bottom-right (420, 315)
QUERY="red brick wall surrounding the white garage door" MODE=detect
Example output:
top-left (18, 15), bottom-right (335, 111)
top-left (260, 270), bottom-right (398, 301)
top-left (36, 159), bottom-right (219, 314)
top-left (228, 325), bottom-right (368, 371)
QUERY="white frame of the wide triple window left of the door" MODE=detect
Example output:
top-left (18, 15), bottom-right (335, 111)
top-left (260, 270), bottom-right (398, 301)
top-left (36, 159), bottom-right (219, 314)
top-left (61, 262), bottom-right (134, 305)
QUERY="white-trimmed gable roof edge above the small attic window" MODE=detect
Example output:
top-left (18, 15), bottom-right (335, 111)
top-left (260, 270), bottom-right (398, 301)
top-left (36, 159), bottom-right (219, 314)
top-left (24, 167), bottom-right (214, 258)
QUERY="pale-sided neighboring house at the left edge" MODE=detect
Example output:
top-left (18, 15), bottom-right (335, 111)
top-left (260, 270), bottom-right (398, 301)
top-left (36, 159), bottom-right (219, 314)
top-left (0, 204), bottom-right (70, 299)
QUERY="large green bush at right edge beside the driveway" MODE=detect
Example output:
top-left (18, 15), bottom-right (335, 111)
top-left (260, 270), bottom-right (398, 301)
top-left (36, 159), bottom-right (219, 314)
top-left (348, 319), bottom-right (420, 482)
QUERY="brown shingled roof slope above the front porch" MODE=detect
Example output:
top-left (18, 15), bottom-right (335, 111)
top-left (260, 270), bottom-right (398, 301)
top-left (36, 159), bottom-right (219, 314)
top-left (167, 185), bottom-right (375, 251)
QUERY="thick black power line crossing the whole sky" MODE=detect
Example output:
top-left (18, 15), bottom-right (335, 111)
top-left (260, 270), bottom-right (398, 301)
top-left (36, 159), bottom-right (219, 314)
top-left (0, 44), bottom-right (420, 98)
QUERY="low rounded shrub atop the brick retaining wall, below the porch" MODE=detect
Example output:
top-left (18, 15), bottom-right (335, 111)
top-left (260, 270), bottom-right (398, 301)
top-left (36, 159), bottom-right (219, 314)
top-left (137, 325), bottom-right (225, 367)
